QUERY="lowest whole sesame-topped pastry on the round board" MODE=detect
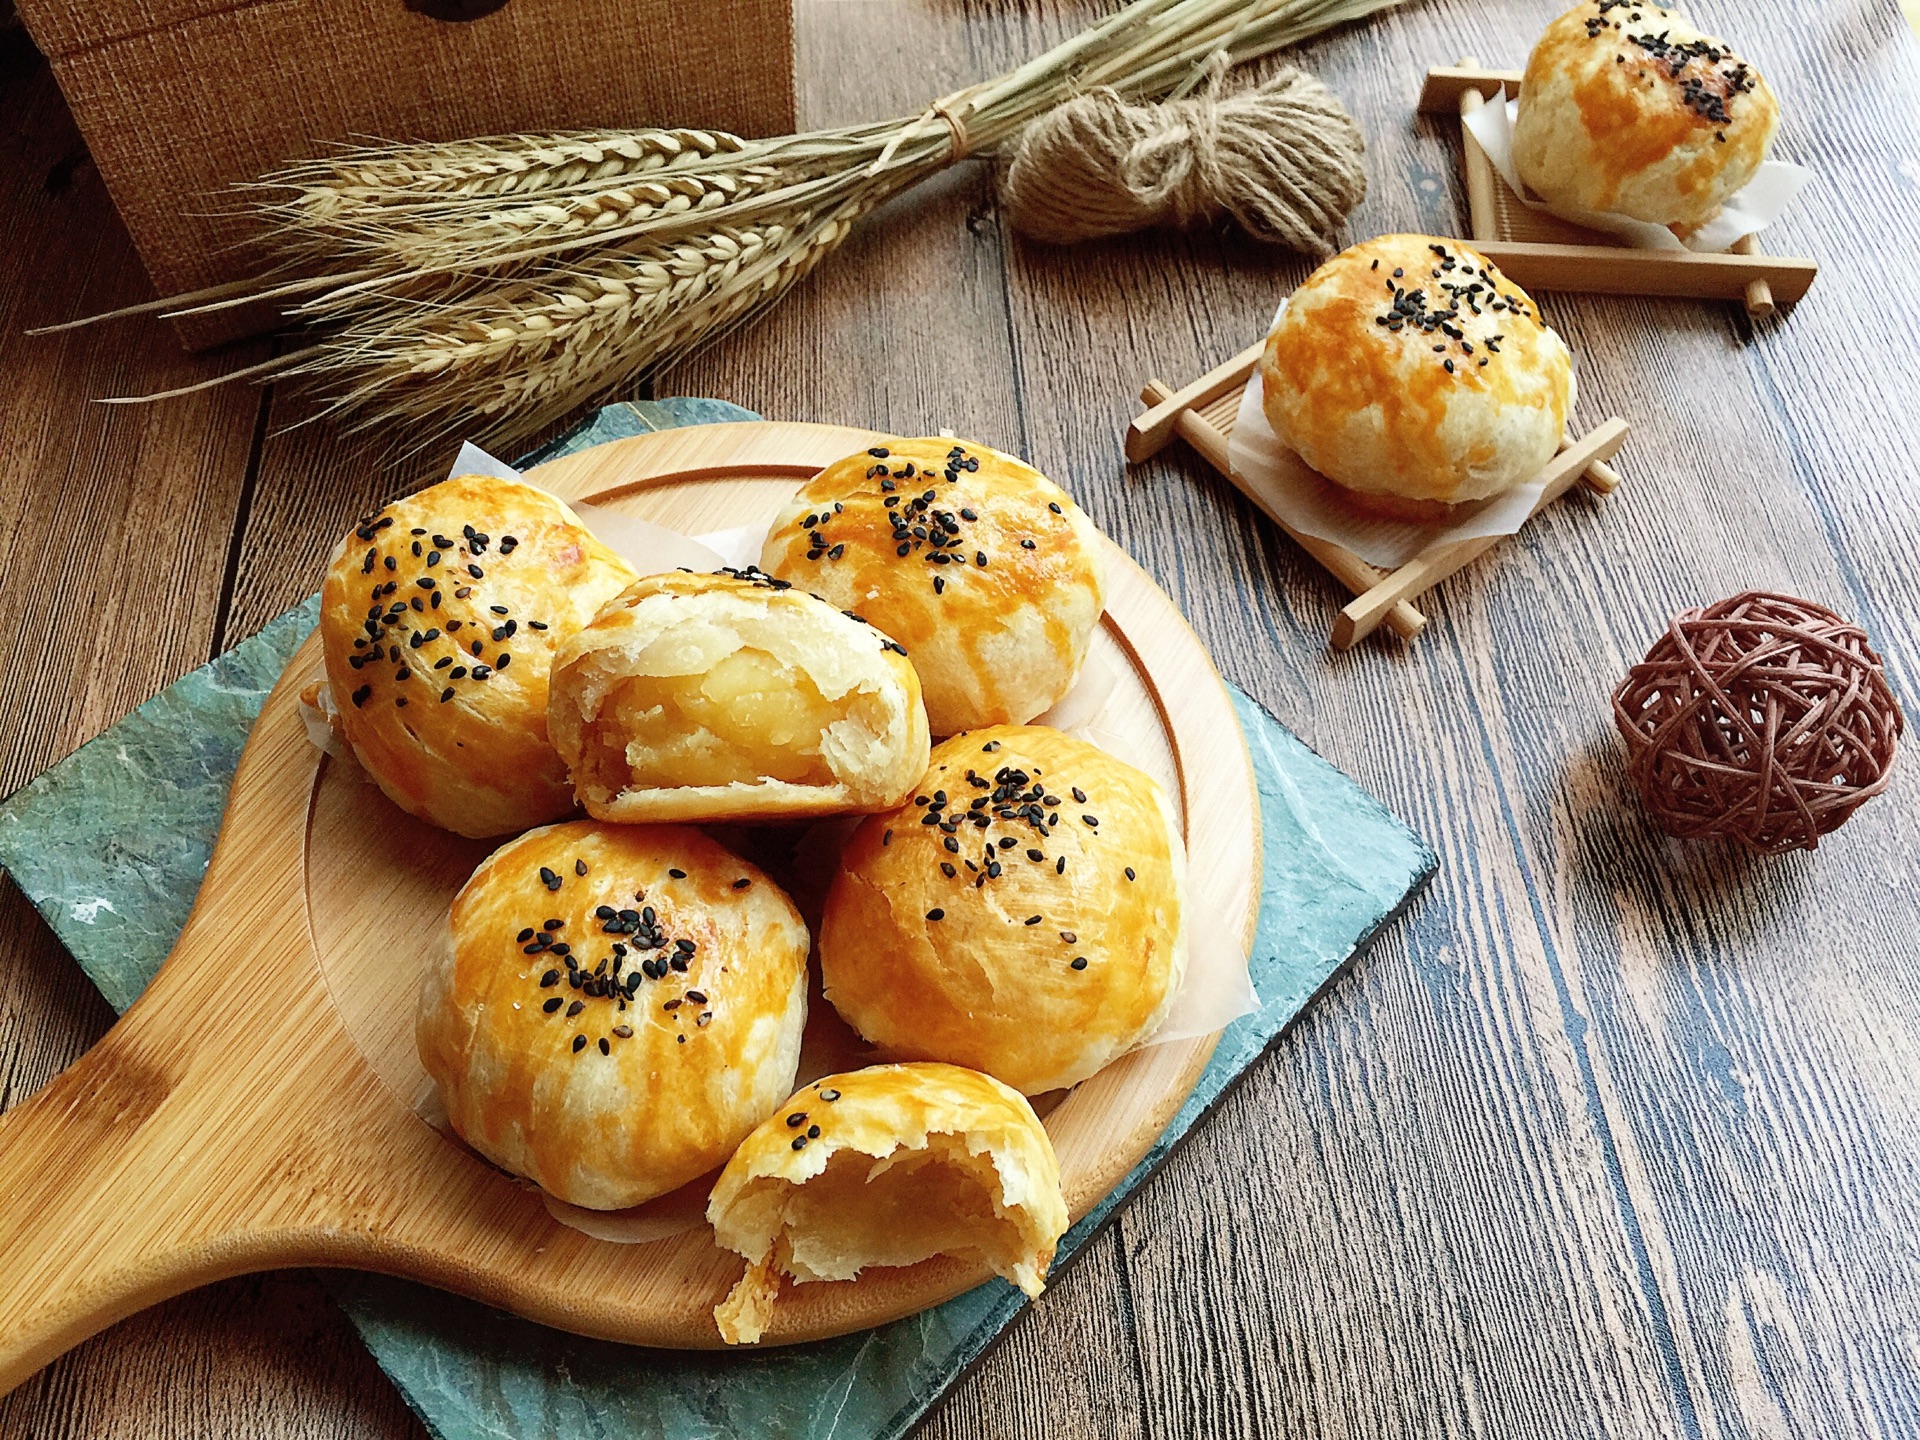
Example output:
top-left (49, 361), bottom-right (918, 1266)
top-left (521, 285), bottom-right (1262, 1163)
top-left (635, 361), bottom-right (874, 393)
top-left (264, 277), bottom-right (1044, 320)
top-left (415, 820), bottom-right (808, 1210)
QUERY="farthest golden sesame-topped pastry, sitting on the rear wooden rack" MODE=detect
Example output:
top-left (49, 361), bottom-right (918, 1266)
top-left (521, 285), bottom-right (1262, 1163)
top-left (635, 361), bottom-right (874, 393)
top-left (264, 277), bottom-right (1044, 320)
top-left (1513, 0), bottom-right (1780, 232)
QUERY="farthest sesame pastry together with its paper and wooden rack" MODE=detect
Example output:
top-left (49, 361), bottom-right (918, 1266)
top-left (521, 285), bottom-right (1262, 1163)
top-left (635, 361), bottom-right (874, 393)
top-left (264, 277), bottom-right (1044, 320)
top-left (1419, 0), bottom-right (1820, 321)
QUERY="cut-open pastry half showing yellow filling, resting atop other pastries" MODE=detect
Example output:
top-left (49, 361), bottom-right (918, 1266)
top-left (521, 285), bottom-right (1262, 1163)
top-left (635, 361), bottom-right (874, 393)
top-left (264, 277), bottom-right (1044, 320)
top-left (547, 570), bottom-right (927, 822)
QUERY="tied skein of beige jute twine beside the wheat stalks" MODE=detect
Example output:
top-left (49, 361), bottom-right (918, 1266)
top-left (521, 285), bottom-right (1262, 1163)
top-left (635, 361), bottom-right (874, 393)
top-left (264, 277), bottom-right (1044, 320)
top-left (1000, 58), bottom-right (1367, 255)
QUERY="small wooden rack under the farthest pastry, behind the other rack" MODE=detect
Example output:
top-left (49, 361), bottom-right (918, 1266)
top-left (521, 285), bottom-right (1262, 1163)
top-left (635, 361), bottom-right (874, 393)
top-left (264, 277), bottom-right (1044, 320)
top-left (1419, 60), bottom-right (1820, 321)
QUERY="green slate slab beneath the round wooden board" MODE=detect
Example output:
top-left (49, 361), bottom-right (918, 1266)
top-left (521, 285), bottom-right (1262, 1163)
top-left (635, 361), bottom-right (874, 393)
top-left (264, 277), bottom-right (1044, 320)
top-left (0, 399), bottom-right (1434, 1440)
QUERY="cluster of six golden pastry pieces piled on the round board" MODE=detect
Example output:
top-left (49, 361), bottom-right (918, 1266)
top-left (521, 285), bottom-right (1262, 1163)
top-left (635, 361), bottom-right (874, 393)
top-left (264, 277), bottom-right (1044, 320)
top-left (321, 438), bottom-right (1187, 1342)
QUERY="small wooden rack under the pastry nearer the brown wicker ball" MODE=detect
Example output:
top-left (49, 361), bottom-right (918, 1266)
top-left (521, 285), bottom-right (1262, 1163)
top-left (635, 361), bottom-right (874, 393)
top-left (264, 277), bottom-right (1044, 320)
top-left (1127, 340), bottom-right (1626, 651)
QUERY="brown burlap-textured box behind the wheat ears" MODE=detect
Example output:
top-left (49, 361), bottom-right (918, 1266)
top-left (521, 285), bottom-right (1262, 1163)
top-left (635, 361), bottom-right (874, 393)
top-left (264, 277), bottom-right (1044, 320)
top-left (17, 0), bottom-right (793, 348)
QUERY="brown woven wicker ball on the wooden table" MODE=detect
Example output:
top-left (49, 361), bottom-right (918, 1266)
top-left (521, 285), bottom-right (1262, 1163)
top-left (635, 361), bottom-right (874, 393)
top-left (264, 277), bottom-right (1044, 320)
top-left (1613, 589), bottom-right (1905, 854)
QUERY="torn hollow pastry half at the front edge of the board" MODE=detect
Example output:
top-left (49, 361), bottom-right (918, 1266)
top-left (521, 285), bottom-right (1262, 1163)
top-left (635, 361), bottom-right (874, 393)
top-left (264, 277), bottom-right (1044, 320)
top-left (707, 1064), bottom-right (1068, 1344)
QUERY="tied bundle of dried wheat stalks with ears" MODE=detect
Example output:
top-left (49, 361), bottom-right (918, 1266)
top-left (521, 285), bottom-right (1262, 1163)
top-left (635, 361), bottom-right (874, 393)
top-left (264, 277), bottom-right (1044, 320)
top-left (52, 0), bottom-right (1398, 451)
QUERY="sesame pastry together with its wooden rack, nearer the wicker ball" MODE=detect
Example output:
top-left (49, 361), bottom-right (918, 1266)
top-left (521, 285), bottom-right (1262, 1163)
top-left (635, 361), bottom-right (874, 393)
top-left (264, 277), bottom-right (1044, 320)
top-left (1127, 234), bottom-right (1628, 649)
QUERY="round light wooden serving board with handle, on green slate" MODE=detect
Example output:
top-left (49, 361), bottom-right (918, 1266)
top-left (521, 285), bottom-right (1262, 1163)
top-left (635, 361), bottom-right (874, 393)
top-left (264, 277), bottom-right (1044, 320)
top-left (0, 422), bottom-right (1260, 1394)
